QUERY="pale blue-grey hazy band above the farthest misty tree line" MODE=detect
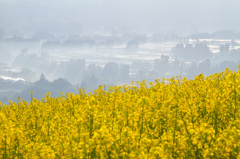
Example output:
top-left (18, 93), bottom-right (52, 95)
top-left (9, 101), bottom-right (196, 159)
top-left (0, 0), bottom-right (240, 33)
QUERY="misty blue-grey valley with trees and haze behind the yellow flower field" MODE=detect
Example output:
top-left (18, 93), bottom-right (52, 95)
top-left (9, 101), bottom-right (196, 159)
top-left (0, 0), bottom-right (240, 103)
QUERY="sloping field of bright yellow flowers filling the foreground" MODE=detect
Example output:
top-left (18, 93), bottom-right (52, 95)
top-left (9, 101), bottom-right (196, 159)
top-left (0, 67), bottom-right (240, 158)
